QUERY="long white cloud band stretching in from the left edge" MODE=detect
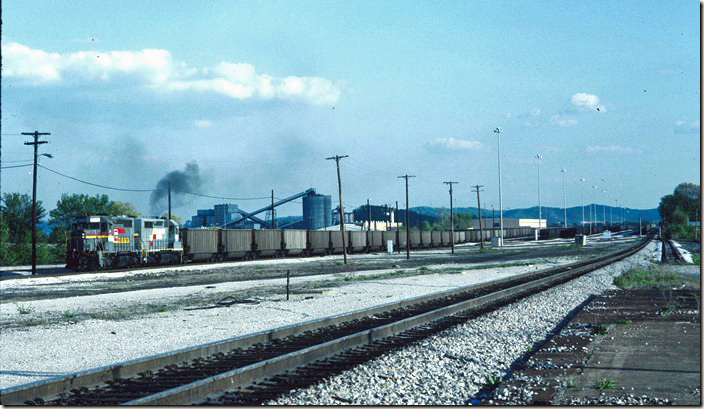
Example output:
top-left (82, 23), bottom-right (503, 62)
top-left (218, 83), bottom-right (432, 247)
top-left (2, 43), bottom-right (340, 104)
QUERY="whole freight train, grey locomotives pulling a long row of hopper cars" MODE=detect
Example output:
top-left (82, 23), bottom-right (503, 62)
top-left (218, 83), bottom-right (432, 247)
top-left (66, 215), bottom-right (603, 271)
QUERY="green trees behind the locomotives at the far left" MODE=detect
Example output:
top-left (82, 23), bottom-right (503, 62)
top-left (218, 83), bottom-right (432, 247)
top-left (0, 193), bottom-right (141, 266)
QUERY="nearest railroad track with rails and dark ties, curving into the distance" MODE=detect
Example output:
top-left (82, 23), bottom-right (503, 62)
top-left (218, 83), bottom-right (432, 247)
top-left (0, 234), bottom-right (653, 405)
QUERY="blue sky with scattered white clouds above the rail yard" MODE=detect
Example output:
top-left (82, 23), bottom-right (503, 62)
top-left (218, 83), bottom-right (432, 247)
top-left (0, 0), bottom-right (701, 220)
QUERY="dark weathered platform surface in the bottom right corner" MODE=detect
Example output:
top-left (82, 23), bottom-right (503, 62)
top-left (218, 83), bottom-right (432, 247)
top-left (485, 289), bottom-right (702, 406)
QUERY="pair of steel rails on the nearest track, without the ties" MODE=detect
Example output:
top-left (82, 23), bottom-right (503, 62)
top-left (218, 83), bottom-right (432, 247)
top-left (0, 231), bottom-right (652, 405)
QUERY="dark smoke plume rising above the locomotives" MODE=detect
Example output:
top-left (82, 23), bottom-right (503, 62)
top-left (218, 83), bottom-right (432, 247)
top-left (149, 162), bottom-right (201, 216)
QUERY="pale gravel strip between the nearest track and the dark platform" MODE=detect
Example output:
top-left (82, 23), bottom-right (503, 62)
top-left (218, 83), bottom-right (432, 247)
top-left (269, 243), bottom-right (654, 405)
